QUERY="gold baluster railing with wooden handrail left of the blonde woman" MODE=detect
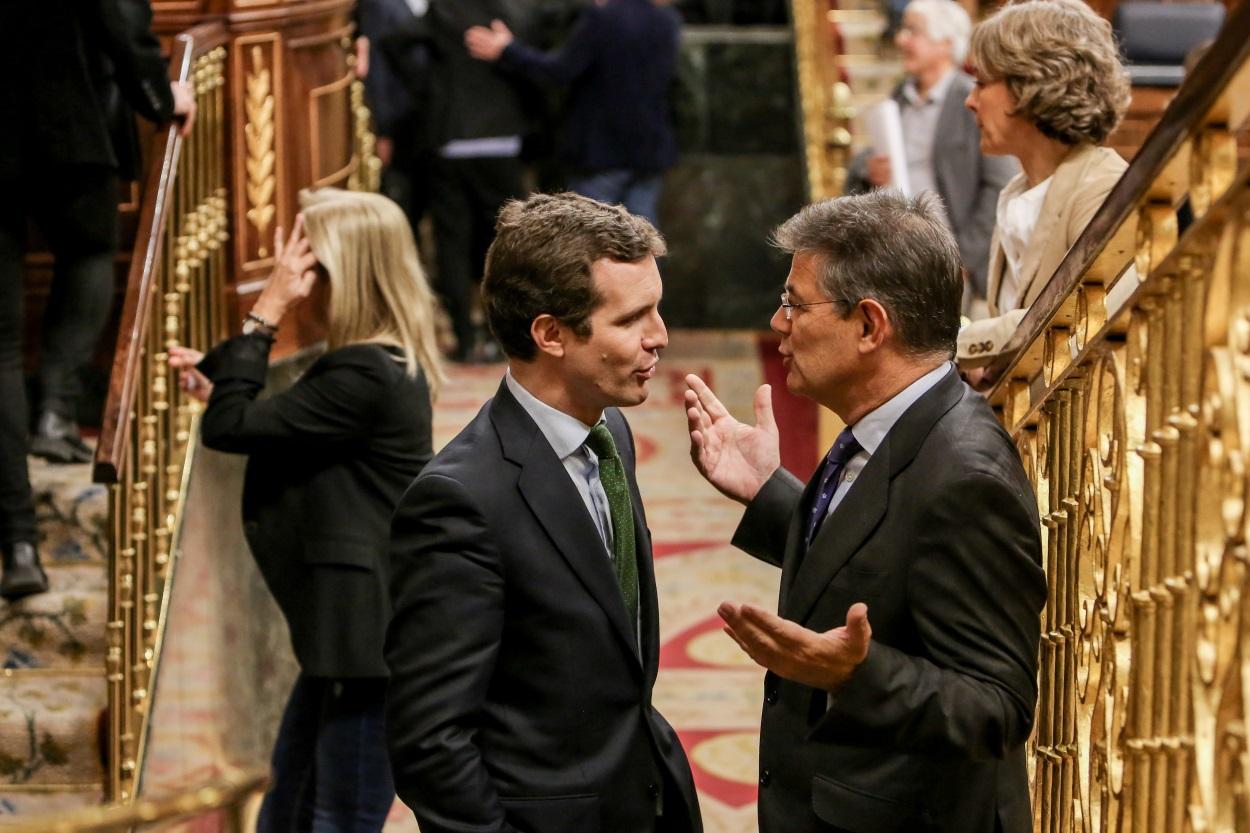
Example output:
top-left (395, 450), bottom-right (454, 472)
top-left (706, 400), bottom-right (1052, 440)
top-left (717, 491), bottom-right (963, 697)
top-left (94, 24), bottom-right (229, 802)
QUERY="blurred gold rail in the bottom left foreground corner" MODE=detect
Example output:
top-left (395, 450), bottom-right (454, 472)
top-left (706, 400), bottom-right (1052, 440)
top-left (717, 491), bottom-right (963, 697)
top-left (5, 772), bottom-right (269, 833)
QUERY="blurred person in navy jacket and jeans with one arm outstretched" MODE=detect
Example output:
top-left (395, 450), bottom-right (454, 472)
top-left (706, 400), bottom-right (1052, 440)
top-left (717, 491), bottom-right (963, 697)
top-left (465, 0), bottom-right (681, 225)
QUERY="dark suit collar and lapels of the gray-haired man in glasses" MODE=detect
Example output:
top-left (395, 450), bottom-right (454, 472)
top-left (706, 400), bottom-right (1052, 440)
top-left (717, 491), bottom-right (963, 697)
top-left (780, 368), bottom-right (966, 622)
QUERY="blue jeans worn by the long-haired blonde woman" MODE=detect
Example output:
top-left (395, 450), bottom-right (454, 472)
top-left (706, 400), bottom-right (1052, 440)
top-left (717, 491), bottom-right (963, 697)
top-left (256, 674), bottom-right (395, 833)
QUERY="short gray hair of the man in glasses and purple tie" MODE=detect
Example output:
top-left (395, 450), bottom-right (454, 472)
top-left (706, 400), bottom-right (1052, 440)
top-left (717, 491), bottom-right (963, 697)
top-left (773, 189), bottom-right (964, 356)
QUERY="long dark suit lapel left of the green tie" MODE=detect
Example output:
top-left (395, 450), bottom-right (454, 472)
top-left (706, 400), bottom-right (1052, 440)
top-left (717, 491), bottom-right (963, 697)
top-left (491, 384), bottom-right (645, 657)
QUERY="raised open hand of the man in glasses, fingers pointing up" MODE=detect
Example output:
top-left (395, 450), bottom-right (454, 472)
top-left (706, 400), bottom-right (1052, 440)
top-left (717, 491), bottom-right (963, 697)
top-left (686, 374), bottom-right (781, 503)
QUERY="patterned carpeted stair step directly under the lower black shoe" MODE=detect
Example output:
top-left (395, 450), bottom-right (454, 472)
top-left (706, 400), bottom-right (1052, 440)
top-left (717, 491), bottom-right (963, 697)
top-left (0, 565), bottom-right (109, 670)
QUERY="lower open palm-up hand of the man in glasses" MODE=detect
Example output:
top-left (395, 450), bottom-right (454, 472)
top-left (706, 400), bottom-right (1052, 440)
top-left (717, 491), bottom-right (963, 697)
top-left (716, 602), bottom-right (873, 692)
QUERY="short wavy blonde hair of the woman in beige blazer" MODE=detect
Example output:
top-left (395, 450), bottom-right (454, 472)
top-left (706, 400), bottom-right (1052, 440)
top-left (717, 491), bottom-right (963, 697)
top-left (971, 0), bottom-right (1130, 145)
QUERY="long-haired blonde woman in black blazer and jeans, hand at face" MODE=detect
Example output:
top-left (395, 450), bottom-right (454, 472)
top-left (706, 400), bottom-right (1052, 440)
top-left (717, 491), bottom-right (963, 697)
top-left (170, 189), bottom-right (441, 833)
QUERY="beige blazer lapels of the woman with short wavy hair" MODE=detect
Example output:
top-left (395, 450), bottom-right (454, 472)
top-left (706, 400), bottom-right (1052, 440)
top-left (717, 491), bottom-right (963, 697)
top-left (985, 145), bottom-right (1100, 316)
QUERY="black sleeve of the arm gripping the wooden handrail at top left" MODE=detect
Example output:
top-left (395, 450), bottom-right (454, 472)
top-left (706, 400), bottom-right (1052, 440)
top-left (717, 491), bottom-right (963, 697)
top-left (99, 0), bottom-right (174, 124)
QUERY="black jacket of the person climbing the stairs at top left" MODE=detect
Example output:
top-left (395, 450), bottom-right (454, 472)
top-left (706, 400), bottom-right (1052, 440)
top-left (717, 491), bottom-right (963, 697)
top-left (0, 0), bottom-right (174, 179)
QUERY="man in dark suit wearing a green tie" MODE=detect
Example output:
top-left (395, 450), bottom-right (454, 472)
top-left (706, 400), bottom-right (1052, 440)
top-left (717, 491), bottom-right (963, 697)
top-left (386, 194), bottom-right (701, 833)
